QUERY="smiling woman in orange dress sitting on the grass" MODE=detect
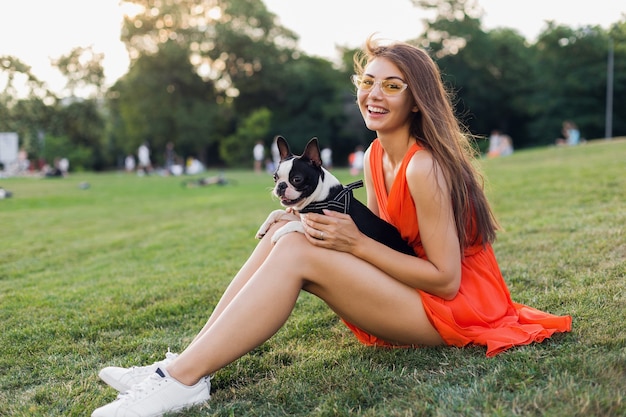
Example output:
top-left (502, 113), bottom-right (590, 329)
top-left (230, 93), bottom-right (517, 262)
top-left (93, 38), bottom-right (571, 416)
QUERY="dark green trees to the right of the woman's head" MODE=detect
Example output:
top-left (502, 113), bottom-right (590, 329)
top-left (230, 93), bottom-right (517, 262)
top-left (414, 0), bottom-right (626, 148)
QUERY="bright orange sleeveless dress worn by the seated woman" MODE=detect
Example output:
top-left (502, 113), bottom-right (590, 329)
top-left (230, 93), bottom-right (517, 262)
top-left (346, 139), bottom-right (572, 356)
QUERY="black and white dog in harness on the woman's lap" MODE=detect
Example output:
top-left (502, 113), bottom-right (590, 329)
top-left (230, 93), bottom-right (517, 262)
top-left (256, 136), bottom-right (415, 255)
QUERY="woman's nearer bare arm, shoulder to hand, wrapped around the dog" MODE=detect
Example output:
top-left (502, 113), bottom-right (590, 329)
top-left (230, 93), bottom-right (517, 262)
top-left (306, 151), bottom-right (461, 299)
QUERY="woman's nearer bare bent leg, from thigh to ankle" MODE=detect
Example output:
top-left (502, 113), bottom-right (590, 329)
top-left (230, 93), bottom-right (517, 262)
top-left (167, 233), bottom-right (443, 385)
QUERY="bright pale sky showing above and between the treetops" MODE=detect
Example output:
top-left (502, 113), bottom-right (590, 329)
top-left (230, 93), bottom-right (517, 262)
top-left (0, 0), bottom-right (626, 95)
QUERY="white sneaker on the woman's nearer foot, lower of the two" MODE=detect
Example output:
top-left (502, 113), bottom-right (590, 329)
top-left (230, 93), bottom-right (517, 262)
top-left (91, 368), bottom-right (211, 417)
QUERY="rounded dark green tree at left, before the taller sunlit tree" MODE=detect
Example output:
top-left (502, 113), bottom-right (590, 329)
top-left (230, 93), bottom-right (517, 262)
top-left (109, 42), bottom-right (220, 164)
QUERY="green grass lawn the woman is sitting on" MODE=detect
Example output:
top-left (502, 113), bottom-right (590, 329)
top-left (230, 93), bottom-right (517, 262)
top-left (0, 140), bottom-right (626, 417)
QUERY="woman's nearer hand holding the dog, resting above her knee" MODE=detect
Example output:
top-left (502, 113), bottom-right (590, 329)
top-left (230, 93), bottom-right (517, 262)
top-left (300, 210), bottom-right (364, 253)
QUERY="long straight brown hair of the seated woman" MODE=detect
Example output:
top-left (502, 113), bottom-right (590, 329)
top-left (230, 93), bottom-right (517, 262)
top-left (354, 36), bottom-right (499, 249)
